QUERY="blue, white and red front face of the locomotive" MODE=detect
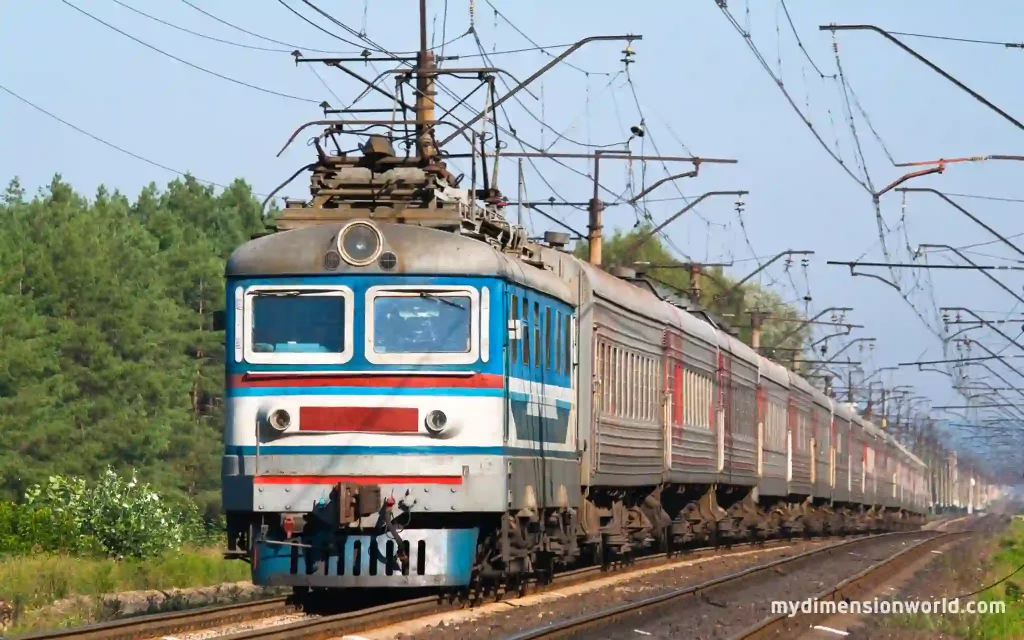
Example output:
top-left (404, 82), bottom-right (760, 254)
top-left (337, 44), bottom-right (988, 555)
top-left (223, 220), bottom-right (507, 588)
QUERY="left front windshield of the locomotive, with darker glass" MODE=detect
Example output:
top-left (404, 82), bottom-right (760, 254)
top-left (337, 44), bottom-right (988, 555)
top-left (252, 291), bottom-right (345, 353)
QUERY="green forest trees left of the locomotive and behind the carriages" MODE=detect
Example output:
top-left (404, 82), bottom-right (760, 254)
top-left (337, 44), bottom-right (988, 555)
top-left (0, 176), bottom-right (803, 517)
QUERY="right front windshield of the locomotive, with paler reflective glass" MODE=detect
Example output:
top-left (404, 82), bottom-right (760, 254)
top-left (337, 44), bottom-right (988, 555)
top-left (374, 291), bottom-right (472, 353)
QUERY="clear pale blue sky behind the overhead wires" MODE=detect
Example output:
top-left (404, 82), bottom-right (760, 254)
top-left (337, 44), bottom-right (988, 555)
top-left (0, 0), bottom-right (1024, 464)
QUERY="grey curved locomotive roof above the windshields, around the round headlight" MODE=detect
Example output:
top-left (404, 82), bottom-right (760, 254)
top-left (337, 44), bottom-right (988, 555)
top-left (225, 222), bottom-right (570, 301)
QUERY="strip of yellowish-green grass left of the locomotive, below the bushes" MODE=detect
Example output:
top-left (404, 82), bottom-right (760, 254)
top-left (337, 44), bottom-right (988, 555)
top-left (0, 549), bottom-right (249, 633)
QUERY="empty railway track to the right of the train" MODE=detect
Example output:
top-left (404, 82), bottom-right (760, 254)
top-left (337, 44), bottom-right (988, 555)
top-left (510, 530), bottom-right (972, 640)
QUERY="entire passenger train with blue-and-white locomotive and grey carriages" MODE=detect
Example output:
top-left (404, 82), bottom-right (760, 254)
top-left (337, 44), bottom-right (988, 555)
top-left (222, 132), bottom-right (987, 593)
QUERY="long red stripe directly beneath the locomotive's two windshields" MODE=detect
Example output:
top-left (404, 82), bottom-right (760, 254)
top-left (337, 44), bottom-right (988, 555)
top-left (227, 372), bottom-right (504, 389)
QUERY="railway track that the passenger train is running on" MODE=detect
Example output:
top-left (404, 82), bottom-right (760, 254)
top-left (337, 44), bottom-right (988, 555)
top-left (18, 536), bottom-right (847, 640)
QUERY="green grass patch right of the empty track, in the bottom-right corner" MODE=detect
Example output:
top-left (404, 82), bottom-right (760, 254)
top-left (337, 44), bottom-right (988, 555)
top-left (885, 519), bottom-right (1024, 640)
